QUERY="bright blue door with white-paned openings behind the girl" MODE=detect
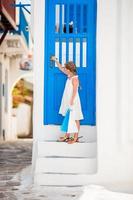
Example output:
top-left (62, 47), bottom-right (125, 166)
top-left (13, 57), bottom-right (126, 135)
top-left (44, 0), bottom-right (96, 126)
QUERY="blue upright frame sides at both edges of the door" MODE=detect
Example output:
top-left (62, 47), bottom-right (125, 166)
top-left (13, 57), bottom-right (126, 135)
top-left (43, 0), bottom-right (97, 126)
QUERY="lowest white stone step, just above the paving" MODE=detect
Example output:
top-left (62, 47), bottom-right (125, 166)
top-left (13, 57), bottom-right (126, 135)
top-left (34, 173), bottom-right (96, 187)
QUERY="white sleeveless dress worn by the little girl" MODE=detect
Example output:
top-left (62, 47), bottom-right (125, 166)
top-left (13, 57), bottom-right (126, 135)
top-left (59, 75), bottom-right (83, 120)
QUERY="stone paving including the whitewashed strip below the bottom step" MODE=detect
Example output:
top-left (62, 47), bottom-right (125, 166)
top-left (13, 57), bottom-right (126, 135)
top-left (0, 139), bottom-right (82, 200)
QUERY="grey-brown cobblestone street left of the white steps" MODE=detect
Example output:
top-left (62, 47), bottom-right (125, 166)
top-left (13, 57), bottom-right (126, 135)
top-left (0, 140), bottom-right (32, 200)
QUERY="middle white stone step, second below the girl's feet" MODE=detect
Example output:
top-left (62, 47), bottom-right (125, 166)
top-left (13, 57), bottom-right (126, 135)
top-left (35, 158), bottom-right (97, 174)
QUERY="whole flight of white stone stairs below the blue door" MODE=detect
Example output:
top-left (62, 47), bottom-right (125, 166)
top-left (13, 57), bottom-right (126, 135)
top-left (35, 126), bottom-right (97, 186)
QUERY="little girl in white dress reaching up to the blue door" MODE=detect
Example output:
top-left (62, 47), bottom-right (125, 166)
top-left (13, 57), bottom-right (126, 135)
top-left (51, 56), bottom-right (83, 144)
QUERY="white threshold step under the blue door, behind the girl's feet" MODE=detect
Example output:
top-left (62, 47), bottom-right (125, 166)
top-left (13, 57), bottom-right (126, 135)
top-left (38, 125), bottom-right (97, 142)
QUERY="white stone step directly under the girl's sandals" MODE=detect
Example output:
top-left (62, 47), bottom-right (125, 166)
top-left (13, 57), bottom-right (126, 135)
top-left (38, 141), bottom-right (97, 158)
